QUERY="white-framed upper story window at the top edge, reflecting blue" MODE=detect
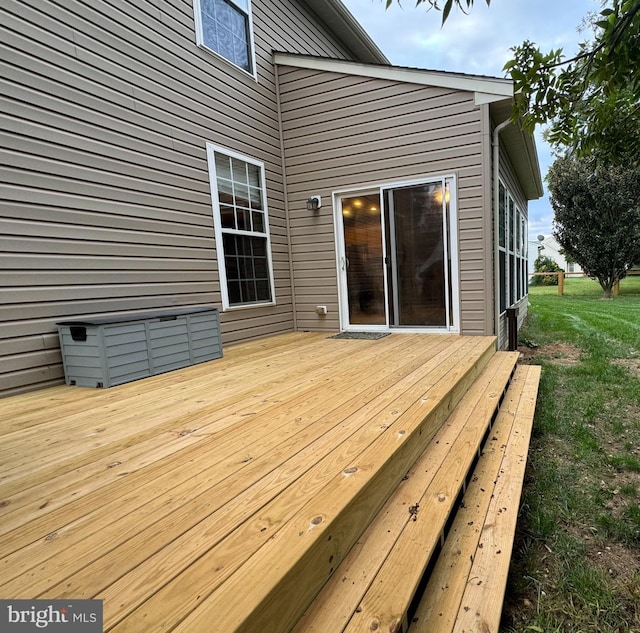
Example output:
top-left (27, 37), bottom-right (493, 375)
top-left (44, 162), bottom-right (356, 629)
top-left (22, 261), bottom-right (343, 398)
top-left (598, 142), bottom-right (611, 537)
top-left (193, 0), bottom-right (255, 74)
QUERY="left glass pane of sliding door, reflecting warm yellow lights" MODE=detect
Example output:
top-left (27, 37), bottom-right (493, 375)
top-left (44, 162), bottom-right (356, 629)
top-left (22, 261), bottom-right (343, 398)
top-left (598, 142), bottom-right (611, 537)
top-left (342, 193), bottom-right (387, 326)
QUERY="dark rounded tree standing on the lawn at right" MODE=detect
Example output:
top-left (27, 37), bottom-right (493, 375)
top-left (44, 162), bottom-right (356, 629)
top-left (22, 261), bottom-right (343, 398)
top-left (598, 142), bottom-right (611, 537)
top-left (547, 155), bottom-right (640, 298)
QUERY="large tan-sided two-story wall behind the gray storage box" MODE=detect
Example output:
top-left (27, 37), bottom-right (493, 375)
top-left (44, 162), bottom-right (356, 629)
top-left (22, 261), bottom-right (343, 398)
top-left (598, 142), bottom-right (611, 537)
top-left (0, 0), bottom-right (358, 394)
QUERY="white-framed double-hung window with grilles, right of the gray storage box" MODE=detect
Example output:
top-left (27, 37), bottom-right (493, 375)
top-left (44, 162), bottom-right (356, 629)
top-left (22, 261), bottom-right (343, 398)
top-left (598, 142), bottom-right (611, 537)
top-left (207, 143), bottom-right (275, 309)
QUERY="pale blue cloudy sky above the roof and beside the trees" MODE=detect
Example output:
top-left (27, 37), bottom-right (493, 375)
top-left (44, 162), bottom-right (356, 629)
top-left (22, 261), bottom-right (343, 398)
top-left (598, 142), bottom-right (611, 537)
top-left (343, 0), bottom-right (600, 240)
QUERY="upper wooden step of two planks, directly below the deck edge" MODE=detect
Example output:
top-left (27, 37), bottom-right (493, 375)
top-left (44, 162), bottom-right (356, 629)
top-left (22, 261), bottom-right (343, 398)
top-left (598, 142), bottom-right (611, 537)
top-left (294, 352), bottom-right (518, 633)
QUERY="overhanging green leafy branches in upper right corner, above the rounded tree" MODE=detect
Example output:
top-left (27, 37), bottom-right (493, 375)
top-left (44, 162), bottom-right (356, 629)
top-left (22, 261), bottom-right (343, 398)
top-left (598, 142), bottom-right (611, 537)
top-left (505, 0), bottom-right (640, 164)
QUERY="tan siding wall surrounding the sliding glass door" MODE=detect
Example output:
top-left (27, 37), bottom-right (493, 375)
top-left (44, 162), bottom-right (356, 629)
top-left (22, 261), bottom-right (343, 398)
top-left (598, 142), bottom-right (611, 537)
top-left (278, 66), bottom-right (490, 335)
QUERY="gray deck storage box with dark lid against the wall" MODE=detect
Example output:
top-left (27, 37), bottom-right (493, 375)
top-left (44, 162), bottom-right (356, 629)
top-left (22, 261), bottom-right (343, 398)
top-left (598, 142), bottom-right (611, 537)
top-left (58, 308), bottom-right (222, 387)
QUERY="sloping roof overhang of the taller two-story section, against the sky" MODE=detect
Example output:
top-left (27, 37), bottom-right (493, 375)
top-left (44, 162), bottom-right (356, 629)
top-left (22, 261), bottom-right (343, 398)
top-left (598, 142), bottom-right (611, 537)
top-left (303, 0), bottom-right (389, 64)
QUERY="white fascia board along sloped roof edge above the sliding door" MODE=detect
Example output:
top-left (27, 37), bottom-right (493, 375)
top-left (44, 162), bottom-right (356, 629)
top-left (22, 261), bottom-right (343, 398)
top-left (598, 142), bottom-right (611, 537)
top-left (273, 53), bottom-right (513, 104)
